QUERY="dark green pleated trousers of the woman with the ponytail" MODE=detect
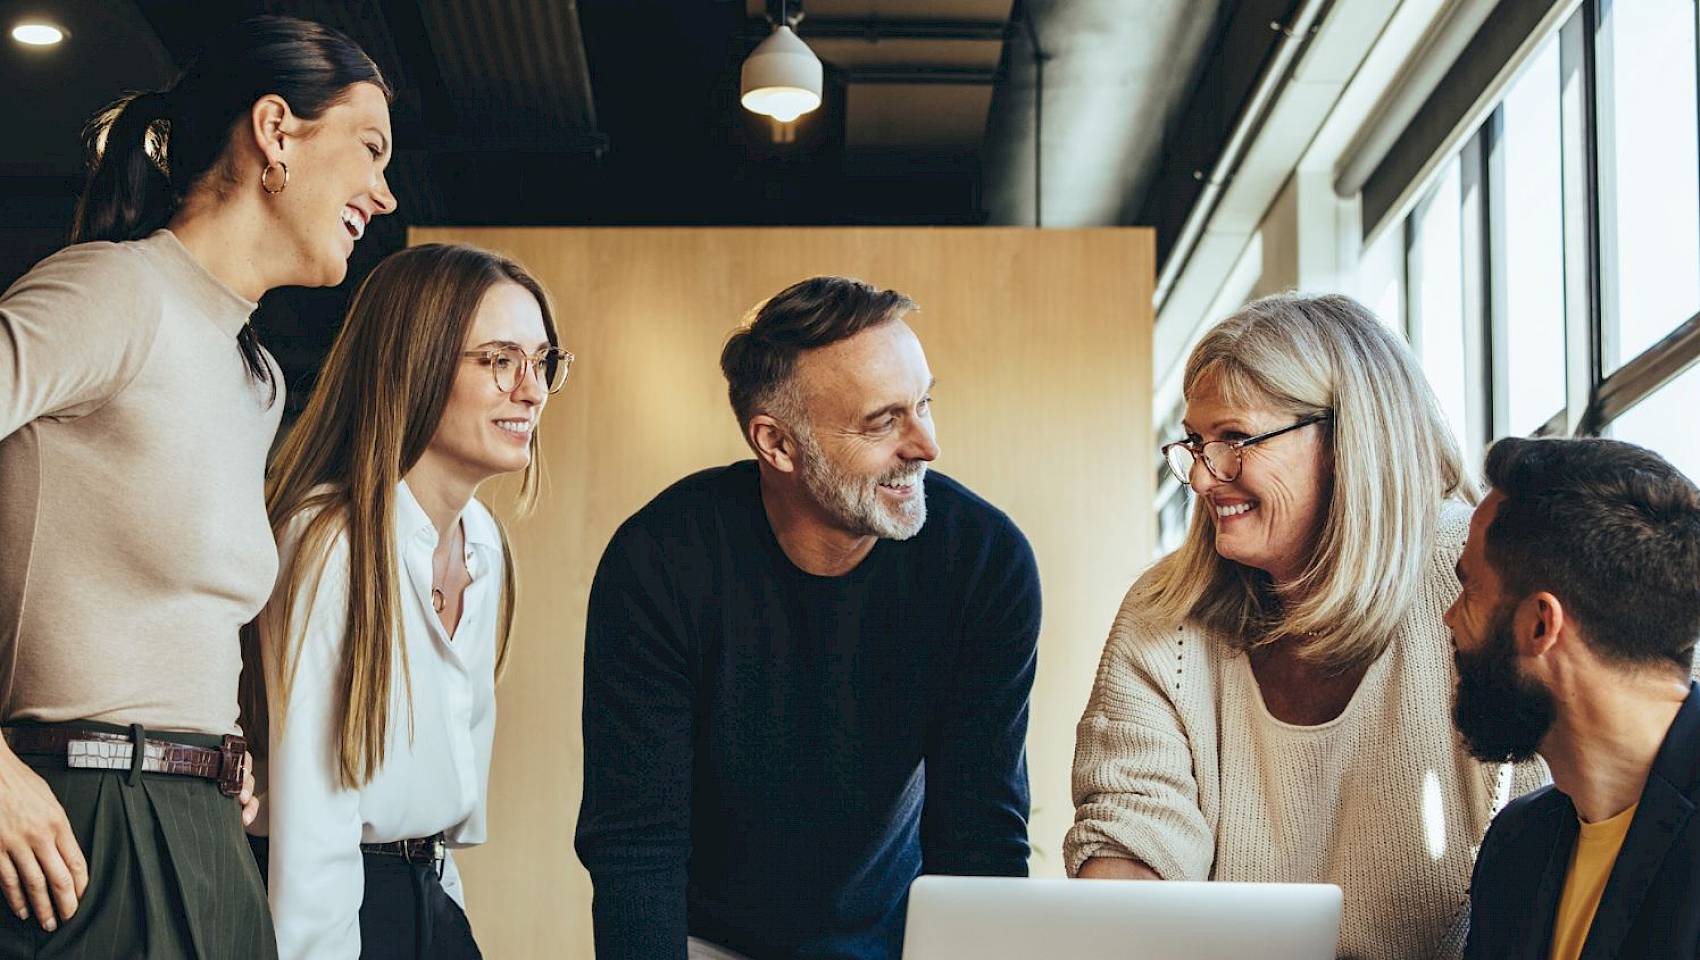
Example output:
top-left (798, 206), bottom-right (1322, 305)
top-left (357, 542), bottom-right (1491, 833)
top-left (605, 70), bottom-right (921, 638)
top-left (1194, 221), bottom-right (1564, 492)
top-left (0, 722), bottom-right (277, 960)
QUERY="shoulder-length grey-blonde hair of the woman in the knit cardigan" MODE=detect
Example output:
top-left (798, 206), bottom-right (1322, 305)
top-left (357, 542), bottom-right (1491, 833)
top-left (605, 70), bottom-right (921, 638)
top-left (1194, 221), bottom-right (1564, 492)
top-left (1134, 294), bottom-right (1477, 669)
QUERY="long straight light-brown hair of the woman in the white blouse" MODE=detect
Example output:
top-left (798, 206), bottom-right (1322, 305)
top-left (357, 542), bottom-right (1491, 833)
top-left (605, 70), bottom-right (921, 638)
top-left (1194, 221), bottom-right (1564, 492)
top-left (241, 243), bottom-right (558, 787)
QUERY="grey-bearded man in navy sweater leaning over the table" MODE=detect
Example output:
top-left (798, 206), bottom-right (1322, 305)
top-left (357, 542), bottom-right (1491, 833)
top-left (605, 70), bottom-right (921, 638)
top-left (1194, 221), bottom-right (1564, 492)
top-left (576, 277), bottom-right (1039, 960)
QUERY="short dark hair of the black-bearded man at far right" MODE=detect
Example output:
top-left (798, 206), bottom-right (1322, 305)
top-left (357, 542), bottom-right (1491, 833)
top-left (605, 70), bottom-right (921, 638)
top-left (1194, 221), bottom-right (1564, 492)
top-left (1484, 437), bottom-right (1700, 673)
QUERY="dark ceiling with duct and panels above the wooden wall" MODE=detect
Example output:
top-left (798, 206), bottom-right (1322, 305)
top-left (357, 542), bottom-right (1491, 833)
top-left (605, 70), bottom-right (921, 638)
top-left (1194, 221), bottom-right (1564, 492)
top-left (0, 0), bottom-right (1267, 396)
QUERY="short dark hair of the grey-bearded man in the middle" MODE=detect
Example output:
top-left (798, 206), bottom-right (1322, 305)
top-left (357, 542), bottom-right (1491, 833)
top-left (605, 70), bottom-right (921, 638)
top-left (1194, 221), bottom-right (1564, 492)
top-left (721, 277), bottom-right (915, 426)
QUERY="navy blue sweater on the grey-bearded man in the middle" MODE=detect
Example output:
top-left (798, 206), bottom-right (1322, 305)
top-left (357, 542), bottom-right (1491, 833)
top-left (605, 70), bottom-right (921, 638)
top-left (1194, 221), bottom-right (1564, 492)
top-left (576, 460), bottom-right (1039, 960)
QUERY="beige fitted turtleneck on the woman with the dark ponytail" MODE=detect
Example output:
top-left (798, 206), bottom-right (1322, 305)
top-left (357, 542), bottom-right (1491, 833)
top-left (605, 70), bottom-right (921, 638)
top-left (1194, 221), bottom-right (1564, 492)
top-left (0, 229), bottom-right (284, 734)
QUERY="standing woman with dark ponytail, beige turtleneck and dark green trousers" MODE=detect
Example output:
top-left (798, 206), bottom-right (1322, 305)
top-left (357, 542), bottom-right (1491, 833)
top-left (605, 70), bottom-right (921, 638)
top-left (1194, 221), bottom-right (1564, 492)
top-left (0, 17), bottom-right (394, 960)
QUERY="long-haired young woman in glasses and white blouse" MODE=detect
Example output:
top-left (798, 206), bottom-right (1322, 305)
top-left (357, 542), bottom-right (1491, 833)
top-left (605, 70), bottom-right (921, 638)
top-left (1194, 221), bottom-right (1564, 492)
top-left (247, 245), bottom-right (573, 960)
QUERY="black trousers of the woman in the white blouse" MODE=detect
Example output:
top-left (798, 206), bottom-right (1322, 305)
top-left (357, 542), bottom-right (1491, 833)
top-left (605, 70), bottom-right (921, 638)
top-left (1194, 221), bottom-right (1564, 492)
top-left (248, 836), bottom-right (483, 960)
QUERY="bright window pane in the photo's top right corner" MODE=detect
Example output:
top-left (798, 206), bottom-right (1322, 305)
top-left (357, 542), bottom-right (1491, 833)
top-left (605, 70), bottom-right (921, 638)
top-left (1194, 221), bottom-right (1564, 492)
top-left (1595, 0), bottom-right (1700, 374)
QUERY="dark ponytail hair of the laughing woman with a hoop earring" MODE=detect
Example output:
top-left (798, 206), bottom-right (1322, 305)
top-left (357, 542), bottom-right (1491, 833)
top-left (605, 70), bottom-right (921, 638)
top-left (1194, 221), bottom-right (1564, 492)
top-left (71, 15), bottom-right (393, 398)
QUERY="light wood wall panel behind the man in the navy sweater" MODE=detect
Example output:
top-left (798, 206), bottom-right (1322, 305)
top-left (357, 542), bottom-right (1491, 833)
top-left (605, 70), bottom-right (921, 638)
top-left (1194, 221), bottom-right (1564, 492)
top-left (411, 228), bottom-right (1156, 958)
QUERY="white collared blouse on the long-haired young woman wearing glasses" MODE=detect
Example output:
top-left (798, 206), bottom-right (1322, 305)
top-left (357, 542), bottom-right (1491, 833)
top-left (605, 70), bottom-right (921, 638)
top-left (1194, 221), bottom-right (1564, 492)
top-left (248, 481), bottom-right (502, 960)
